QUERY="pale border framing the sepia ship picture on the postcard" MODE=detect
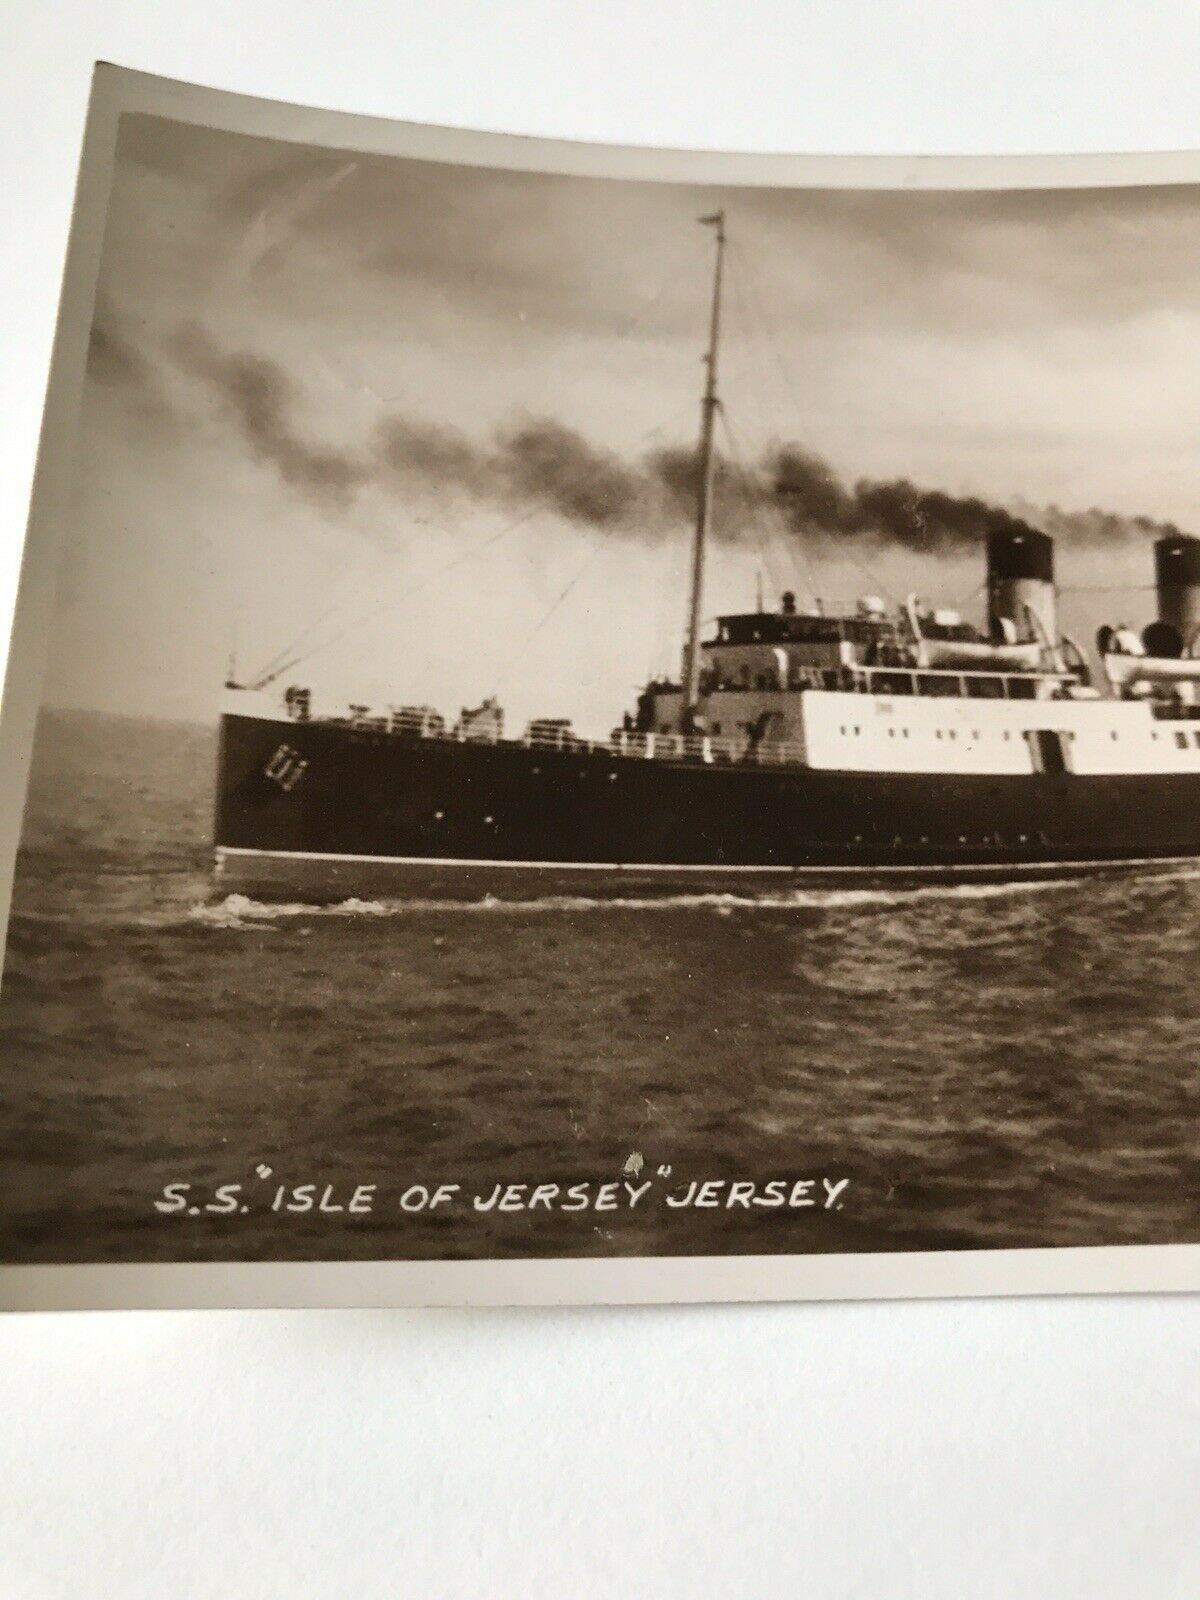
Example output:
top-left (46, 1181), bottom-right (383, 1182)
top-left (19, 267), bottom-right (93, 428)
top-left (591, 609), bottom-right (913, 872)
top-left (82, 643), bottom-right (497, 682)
top-left (0, 64), bottom-right (1200, 1310)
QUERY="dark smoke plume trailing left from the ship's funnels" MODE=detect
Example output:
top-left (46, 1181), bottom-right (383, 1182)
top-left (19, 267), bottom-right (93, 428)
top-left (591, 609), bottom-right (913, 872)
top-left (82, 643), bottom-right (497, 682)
top-left (169, 326), bottom-right (1196, 555)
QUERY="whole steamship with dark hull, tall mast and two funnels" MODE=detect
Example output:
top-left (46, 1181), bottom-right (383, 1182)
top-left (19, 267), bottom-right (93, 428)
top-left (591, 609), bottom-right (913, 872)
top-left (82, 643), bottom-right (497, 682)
top-left (214, 214), bottom-right (1200, 899)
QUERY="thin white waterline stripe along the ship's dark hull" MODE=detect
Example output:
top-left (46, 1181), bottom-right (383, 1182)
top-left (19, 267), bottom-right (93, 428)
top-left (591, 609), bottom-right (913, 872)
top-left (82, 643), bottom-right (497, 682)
top-left (213, 845), bottom-right (1200, 877)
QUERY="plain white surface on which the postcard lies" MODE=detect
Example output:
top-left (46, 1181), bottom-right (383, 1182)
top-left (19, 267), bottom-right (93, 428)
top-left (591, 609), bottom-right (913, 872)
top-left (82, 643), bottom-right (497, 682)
top-left (0, 0), bottom-right (1200, 1600)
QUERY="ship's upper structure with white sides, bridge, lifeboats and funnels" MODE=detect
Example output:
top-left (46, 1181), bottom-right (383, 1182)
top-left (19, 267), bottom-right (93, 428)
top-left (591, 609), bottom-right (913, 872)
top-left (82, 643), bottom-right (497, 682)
top-left (637, 525), bottom-right (1200, 776)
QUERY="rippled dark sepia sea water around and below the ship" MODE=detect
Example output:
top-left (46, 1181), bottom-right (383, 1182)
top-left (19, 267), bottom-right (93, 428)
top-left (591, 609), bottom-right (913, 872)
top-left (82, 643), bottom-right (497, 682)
top-left (0, 712), bottom-right (1200, 1261)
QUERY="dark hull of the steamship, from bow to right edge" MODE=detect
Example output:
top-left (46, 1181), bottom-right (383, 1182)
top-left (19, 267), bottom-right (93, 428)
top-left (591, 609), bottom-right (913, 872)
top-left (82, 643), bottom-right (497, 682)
top-left (216, 715), bottom-right (1200, 901)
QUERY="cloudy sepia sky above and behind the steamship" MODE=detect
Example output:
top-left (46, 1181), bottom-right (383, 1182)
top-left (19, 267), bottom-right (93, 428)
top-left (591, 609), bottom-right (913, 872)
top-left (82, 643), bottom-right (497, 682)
top-left (48, 117), bottom-right (1200, 731)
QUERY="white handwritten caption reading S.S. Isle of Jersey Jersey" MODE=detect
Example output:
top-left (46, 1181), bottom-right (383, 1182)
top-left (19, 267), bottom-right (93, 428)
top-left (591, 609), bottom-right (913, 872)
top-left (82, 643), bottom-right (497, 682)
top-left (154, 1165), bottom-right (850, 1216)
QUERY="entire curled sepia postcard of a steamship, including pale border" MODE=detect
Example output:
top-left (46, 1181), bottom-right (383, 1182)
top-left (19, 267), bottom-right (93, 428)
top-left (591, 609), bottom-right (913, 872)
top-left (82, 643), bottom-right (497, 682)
top-left (0, 67), bottom-right (1200, 1307)
